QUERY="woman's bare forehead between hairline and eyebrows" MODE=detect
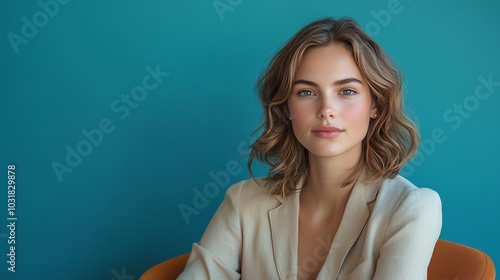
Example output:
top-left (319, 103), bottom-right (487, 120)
top-left (295, 44), bottom-right (363, 81)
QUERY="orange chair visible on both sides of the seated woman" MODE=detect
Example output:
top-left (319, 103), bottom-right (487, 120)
top-left (140, 239), bottom-right (495, 280)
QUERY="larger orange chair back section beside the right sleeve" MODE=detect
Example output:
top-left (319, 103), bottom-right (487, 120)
top-left (427, 239), bottom-right (495, 280)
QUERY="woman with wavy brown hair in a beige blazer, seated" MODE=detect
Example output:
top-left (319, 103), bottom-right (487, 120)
top-left (178, 18), bottom-right (441, 280)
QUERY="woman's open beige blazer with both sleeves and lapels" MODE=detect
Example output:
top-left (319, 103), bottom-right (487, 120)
top-left (178, 176), bottom-right (441, 280)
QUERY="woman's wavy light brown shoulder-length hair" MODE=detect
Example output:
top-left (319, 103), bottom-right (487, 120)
top-left (248, 18), bottom-right (420, 195)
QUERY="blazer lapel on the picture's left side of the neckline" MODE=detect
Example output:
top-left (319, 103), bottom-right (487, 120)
top-left (269, 189), bottom-right (299, 280)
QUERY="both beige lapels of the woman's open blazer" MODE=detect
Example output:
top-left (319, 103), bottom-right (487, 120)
top-left (269, 178), bottom-right (380, 279)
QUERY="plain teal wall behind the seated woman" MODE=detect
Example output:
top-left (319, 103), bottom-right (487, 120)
top-left (0, 0), bottom-right (500, 280)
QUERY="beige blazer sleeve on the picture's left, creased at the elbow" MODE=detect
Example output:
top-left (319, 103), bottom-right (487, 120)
top-left (177, 182), bottom-right (243, 280)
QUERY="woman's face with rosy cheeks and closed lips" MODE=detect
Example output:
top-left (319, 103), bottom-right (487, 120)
top-left (288, 44), bottom-right (376, 160)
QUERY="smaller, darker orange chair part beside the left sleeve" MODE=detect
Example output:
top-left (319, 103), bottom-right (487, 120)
top-left (140, 254), bottom-right (189, 280)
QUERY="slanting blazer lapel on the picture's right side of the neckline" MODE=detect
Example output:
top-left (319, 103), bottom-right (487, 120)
top-left (318, 180), bottom-right (379, 279)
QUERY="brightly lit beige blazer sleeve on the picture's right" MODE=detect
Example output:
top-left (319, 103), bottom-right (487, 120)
top-left (373, 188), bottom-right (442, 280)
